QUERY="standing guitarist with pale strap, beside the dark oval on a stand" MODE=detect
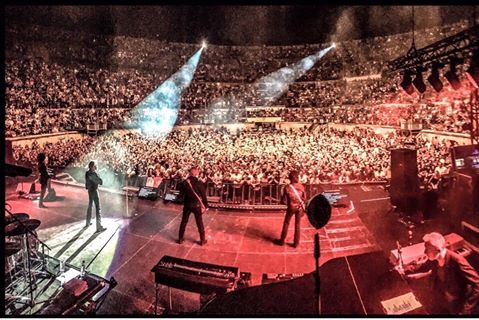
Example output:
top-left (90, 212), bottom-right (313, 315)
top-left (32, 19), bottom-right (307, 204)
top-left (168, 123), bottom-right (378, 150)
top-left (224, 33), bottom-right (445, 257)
top-left (273, 170), bottom-right (306, 248)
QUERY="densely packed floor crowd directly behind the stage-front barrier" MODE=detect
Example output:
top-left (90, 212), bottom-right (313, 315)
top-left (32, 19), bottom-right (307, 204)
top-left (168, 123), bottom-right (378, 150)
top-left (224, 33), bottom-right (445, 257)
top-left (10, 126), bottom-right (452, 190)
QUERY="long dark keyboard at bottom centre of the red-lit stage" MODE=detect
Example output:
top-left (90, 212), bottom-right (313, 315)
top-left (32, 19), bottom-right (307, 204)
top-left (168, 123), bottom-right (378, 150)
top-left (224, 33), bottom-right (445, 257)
top-left (151, 256), bottom-right (240, 294)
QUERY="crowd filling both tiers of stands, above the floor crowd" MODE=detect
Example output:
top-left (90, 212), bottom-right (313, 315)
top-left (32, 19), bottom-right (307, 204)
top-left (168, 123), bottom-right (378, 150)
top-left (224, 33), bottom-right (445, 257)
top-left (5, 22), bottom-right (476, 137)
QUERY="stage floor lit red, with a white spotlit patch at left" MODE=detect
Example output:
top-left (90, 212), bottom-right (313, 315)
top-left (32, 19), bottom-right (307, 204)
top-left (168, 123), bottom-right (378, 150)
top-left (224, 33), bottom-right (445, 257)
top-left (6, 183), bottom-right (464, 315)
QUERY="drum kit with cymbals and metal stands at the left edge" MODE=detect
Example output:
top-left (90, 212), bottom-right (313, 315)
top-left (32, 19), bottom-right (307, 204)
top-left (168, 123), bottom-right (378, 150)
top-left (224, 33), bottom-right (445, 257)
top-left (5, 208), bottom-right (52, 306)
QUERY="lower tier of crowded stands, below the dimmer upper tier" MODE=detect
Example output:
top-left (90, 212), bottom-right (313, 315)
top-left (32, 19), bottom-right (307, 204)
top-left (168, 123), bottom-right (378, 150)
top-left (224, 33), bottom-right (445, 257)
top-left (5, 52), bottom-right (471, 137)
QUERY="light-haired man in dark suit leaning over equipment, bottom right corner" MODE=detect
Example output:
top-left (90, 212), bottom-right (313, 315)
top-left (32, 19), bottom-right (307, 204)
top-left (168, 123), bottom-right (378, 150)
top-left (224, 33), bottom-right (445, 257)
top-left (398, 232), bottom-right (479, 315)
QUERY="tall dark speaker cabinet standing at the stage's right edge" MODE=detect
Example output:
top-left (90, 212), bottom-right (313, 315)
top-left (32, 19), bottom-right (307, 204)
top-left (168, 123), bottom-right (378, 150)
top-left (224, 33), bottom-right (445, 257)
top-left (389, 148), bottom-right (420, 214)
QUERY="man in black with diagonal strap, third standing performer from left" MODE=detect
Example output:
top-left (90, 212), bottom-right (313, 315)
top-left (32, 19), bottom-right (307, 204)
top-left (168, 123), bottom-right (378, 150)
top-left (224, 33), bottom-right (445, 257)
top-left (178, 167), bottom-right (208, 245)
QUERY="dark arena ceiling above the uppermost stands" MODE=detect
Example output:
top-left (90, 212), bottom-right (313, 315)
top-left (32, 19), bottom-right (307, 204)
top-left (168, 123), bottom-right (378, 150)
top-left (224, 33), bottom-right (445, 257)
top-left (5, 5), bottom-right (477, 45)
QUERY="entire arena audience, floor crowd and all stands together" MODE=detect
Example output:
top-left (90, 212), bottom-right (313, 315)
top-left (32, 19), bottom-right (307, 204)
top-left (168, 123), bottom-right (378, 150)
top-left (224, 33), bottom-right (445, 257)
top-left (5, 18), bottom-right (471, 190)
